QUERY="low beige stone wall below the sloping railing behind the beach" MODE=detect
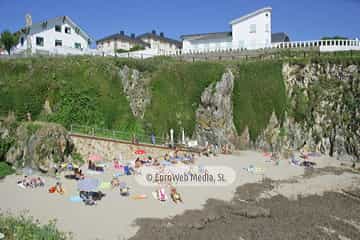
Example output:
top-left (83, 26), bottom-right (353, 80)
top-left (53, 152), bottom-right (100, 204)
top-left (71, 134), bottom-right (194, 161)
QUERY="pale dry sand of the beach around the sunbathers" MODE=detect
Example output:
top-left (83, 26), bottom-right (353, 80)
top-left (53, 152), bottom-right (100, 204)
top-left (0, 151), bottom-right (360, 240)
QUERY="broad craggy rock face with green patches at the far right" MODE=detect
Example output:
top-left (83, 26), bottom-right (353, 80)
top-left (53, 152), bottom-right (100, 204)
top-left (257, 63), bottom-right (360, 160)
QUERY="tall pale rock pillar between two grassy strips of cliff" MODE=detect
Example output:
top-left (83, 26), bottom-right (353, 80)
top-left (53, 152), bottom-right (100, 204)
top-left (195, 70), bottom-right (237, 146)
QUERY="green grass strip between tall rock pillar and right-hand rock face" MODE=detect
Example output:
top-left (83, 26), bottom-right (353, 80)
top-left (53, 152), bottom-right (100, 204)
top-left (232, 61), bottom-right (287, 140)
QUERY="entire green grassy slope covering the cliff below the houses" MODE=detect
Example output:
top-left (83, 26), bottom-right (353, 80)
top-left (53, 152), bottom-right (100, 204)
top-left (0, 56), bottom-right (354, 142)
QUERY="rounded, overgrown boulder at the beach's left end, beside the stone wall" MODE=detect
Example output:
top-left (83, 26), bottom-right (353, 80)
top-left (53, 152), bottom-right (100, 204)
top-left (6, 122), bottom-right (74, 173)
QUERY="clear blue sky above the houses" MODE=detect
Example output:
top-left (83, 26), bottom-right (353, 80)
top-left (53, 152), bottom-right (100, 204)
top-left (0, 0), bottom-right (360, 44)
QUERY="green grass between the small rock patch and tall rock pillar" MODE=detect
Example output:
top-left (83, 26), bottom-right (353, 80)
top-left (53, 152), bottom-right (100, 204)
top-left (144, 62), bottom-right (225, 136)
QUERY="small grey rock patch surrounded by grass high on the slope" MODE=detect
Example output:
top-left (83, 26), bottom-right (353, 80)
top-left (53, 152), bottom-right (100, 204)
top-left (119, 66), bottom-right (150, 118)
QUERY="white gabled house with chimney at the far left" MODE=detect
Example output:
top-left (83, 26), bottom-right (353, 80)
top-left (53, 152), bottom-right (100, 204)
top-left (14, 15), bottom-right (92, 55)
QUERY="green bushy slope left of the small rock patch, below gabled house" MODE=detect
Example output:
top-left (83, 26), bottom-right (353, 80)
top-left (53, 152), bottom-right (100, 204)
top-left (0, 57), bottom-right (139, 130)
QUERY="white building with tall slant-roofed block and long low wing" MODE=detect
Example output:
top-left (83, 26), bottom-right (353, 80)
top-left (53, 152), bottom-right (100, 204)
top-left (181, 7), bottom-right (280, 53)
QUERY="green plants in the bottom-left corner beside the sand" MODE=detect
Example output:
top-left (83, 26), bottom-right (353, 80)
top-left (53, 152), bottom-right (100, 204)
top-left (0, 213), bottom-right (72, 240)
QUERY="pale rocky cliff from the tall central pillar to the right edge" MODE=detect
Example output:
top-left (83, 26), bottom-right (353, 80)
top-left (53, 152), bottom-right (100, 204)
top-left (195, 63), bottom-right (360, 160)
